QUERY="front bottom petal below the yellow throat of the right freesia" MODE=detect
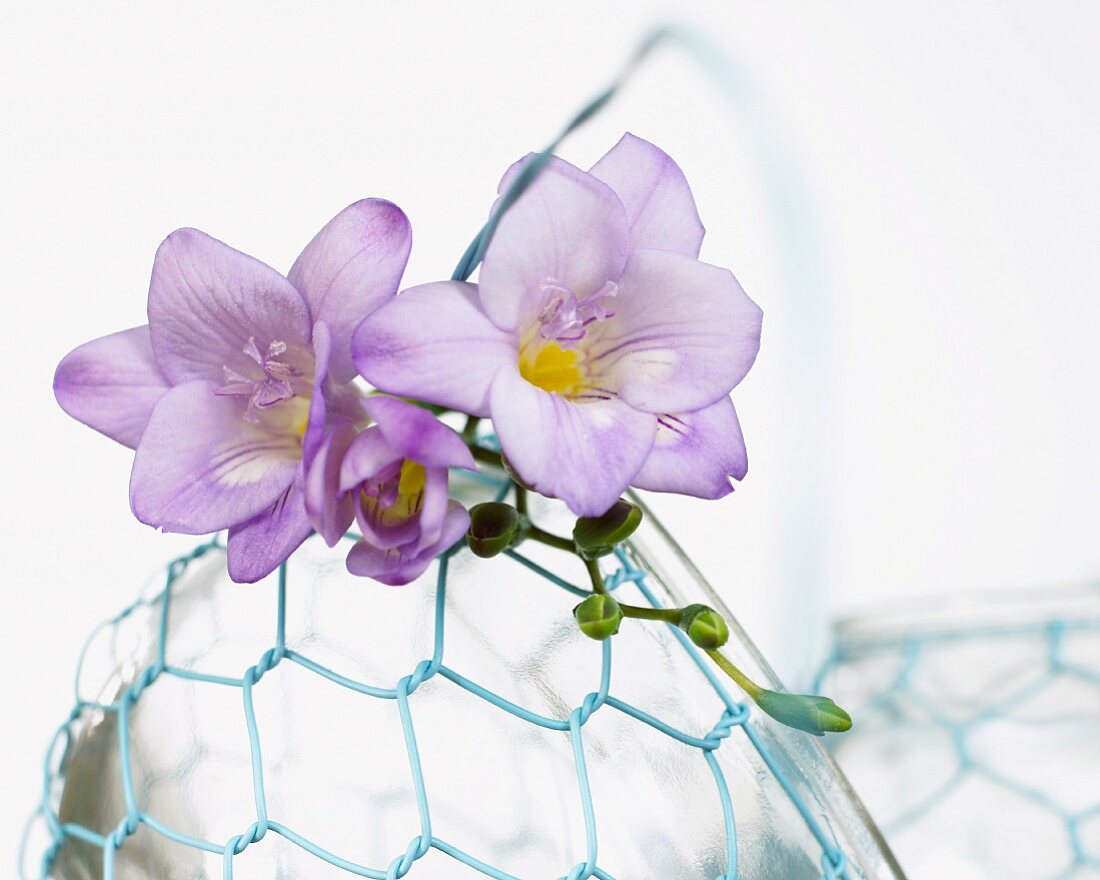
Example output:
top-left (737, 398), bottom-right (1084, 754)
top-left (492, 371), bottom-right (657, 516)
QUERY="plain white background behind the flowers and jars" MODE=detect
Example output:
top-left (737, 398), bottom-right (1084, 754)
top-left (0, 0), bottom-right (1100, 860)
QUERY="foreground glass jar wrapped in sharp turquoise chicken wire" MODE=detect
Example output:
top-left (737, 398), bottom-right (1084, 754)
top-left (23, 485), bottom-right (902, 880)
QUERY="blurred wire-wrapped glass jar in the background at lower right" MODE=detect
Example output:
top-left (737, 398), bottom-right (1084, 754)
top-left (817, 586), bottom-right (1100, 880)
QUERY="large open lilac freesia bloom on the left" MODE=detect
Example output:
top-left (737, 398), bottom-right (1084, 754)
top-left (54, 199), bottom-right (411, 582)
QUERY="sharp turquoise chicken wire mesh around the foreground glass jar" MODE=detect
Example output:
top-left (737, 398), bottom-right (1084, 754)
top-left (20, 537), bottom-right (861, 880)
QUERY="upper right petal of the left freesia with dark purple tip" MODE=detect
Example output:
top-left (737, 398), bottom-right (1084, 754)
top-left (287, 199), bottom-right (413, 382)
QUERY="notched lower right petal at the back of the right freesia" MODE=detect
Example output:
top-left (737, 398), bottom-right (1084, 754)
top-left (630, 397), bottom-right (749, 498)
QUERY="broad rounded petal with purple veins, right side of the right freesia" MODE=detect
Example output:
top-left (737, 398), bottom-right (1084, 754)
top-left (587, 251), bottom-right (762, 413)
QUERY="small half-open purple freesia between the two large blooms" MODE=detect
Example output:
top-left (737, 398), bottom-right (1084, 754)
top-left (306, 397), bottom-right (476, 585)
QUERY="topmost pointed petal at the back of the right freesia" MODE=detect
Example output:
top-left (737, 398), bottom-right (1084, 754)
top-left (590, 133), bottom-right (704, 256)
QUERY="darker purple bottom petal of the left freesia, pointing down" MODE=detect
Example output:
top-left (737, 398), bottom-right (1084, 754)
top-left (227, 484), bottom-right (314, 584)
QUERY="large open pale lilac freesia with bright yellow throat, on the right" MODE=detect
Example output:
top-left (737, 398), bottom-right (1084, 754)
top-left (352, 134), bottom-right (761, 516)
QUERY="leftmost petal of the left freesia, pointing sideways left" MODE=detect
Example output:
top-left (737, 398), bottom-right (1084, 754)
top-left (54, 326), bottom-right (169, 449)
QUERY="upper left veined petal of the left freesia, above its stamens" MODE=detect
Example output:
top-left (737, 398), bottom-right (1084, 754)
top-left (149, 229), bottom-right (310, 384)
